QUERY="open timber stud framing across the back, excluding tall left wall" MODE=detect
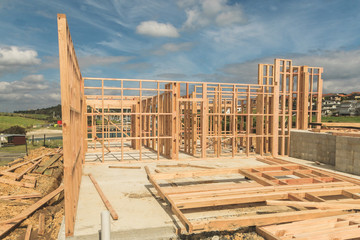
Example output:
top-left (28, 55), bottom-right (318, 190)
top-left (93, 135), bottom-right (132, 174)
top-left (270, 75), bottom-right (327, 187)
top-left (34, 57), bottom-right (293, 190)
top-left (83, 59), bottom-right (322, 162)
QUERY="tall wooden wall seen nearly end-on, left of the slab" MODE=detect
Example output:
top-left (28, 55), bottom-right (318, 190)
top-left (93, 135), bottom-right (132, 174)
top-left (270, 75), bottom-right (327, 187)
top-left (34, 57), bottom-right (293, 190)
top-left (57, 14), bottom-right (87, 236)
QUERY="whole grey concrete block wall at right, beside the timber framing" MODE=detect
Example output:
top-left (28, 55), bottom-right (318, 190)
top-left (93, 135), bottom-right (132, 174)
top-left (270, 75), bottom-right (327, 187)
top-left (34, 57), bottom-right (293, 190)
top-left (289, 130), bottom-right (360, 175)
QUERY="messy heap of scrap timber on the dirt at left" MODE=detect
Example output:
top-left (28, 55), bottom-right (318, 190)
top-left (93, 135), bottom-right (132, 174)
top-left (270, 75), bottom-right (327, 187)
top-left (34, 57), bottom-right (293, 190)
top-left (0, 148), bottom-right (64, 239)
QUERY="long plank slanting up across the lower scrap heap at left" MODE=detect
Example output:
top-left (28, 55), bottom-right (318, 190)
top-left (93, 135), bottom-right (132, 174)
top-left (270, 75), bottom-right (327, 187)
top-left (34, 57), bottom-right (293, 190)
top-left (0, 185), bottom-right (64, 238)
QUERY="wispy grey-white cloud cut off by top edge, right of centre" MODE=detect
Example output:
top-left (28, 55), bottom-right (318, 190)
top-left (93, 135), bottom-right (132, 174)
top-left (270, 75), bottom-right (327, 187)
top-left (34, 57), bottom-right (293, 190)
top-left (178, 0), bottom-right (247, 29)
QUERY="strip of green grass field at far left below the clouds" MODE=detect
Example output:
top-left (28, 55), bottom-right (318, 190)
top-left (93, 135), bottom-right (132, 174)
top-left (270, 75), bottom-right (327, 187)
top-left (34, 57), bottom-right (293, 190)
top-left (0, 115), bottom-right (48, 131)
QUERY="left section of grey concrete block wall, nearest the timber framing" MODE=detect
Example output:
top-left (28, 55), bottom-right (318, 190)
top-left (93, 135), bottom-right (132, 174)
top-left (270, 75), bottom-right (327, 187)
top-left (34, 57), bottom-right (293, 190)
top-left (289, 130), bottom-right (336, 165)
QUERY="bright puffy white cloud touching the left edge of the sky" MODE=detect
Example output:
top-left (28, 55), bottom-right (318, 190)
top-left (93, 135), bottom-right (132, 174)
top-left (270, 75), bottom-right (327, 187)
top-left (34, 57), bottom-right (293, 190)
top-left (0, 46), bottom-right (41, 71)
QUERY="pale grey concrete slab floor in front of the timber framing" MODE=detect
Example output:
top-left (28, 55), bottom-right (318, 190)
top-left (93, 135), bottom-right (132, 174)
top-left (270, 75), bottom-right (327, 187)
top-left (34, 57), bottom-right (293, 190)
top-left (67, 157), bottom-right (265, 239)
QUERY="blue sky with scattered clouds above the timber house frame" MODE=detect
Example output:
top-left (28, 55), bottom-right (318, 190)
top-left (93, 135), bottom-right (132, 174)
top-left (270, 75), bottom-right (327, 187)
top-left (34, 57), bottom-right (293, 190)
top-left (0, 0), bottom-right (360, 111)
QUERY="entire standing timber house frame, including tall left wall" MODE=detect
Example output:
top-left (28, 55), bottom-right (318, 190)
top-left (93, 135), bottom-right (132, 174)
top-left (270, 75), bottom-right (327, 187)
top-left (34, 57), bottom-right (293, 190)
top-left (58, 14), bottom-right (323, 235)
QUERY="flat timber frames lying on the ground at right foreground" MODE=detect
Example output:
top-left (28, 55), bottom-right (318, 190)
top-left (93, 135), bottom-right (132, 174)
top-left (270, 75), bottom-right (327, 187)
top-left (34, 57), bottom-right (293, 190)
top-left (145, 158), bottom-right (360, 239)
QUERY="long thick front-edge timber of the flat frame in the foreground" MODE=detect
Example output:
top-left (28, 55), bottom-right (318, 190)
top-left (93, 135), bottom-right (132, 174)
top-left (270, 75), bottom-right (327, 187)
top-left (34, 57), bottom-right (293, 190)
top-left (193, 209), bottom-right (344, 232)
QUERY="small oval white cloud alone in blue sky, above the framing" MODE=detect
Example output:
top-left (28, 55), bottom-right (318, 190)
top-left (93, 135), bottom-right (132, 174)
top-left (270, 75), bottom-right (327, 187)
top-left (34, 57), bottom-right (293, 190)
top-left (136, 21), bottom-right (180, 38)
